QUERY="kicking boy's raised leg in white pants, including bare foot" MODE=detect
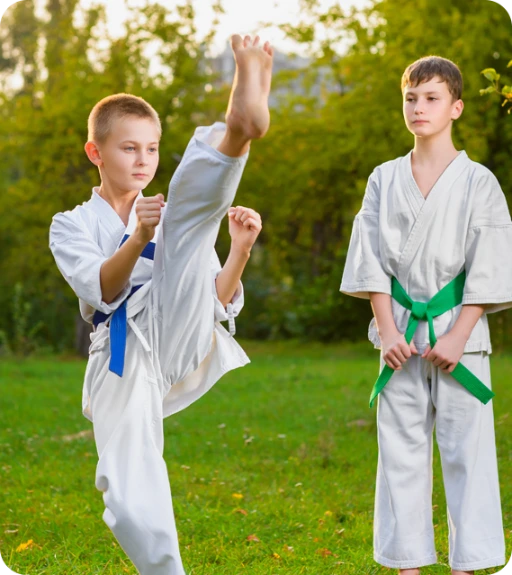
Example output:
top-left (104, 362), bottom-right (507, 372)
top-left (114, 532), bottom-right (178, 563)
top-left (150, 36), bottom-right (272, 387)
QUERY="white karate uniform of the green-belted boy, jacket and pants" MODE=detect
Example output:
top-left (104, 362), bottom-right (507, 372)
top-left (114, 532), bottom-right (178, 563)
top-left (340, 152), bottom-right (512, 570)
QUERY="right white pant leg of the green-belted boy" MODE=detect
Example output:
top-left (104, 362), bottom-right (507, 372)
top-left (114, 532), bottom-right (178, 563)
top-left (433, 352), bottom-right (506, 572)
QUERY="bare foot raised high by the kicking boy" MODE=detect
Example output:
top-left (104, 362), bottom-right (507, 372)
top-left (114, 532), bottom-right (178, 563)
top-left (226, 34), bottom-right (274, 140)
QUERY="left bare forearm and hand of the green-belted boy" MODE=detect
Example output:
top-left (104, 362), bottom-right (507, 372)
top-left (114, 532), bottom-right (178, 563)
top-left (369, 292), bottom-right (418, 370)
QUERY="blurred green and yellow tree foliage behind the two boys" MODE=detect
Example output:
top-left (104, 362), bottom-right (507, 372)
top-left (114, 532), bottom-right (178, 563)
top-left (0, 0), bottom-right (512, 349)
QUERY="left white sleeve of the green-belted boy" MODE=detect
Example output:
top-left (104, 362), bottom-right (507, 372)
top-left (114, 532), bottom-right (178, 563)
top-left (340, 171), bottom-right (391, 299)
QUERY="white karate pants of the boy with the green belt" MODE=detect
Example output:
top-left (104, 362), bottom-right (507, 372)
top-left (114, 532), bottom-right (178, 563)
top-left (374, 352), bottom-right (506, 571)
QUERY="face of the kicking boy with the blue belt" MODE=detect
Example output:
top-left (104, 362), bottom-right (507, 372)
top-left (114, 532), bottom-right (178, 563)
top-left (86, 116), bottom-right (160, 193)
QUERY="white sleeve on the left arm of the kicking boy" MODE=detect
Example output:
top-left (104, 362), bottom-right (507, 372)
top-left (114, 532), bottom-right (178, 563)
top-left (50, 213), bottom-right (131, 314)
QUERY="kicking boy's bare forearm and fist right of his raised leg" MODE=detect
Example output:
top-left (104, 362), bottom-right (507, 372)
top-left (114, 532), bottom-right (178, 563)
top-left (215, 206), bottom-right (262, 307)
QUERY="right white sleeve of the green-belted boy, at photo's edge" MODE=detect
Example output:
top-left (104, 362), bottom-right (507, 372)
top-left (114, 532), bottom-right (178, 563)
top-left (462, 176), bottom-right (512, 313)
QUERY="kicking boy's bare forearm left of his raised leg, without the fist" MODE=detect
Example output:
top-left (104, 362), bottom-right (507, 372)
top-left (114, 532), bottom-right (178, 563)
top-left (100, 232), bottom-right (147, 303)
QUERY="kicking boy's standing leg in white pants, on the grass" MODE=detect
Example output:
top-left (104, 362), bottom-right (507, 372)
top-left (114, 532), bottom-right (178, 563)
top-left (91, 330), bottom-right (185, 575)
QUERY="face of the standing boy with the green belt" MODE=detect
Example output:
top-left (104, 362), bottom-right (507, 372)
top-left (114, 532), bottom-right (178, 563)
top-left (404, 76), bottom-right (464, 138)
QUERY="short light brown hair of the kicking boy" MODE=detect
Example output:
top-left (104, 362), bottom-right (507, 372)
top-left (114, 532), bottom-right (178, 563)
top-left (87, 93), bottom-right (162, 144)
